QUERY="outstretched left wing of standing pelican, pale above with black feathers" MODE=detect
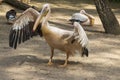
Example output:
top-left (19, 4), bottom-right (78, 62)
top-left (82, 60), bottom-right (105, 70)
top-left (9, 8), bottom-right (41, 49)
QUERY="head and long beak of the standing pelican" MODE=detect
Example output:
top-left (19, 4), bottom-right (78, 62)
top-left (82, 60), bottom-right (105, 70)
top-left (33, 4), bottom-right (50, 31)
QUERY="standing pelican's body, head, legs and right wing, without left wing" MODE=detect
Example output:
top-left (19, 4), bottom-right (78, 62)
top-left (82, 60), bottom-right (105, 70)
top-left (33, 4), bottom-right (88, 67)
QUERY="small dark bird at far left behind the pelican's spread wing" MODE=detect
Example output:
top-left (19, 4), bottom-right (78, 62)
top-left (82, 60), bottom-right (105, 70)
top-left (6, 9), bottom-right (16, 23)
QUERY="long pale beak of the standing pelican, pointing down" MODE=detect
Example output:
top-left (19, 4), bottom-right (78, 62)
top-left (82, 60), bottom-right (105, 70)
top-left (33, 8), bottom-right (48, 32)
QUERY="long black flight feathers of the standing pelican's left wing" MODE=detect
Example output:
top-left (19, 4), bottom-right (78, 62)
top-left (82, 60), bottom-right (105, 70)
top-left (9, 22), bottom-right (43, 49)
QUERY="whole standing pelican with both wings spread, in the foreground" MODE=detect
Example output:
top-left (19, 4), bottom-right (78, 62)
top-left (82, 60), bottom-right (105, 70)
top-left (9, 4), bottom-right (88, 67)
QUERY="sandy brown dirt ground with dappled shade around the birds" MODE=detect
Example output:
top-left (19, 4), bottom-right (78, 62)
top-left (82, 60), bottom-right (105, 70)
top-left (0, 0), bottom-right (120, 80)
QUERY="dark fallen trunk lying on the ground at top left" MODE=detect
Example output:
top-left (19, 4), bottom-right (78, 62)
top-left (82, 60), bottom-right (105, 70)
top-left (3, 0), bottom-right (39, 11)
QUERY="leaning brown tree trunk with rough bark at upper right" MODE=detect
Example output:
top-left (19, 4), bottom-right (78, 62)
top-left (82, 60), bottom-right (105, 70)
top-left (94, 0), bottom-right (120, 34)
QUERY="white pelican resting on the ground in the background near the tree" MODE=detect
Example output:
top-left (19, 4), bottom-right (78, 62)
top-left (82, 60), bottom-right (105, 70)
top-left (69, 10), bottom-right (95, 26)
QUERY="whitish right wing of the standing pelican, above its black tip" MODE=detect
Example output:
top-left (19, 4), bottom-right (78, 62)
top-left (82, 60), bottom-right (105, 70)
top-left (66, 22), bottom-right (88, 47)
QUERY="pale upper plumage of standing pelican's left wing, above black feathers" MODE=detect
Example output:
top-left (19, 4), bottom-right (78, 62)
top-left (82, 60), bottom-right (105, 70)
top-left (13, 8), bottom-right (40, 30)
